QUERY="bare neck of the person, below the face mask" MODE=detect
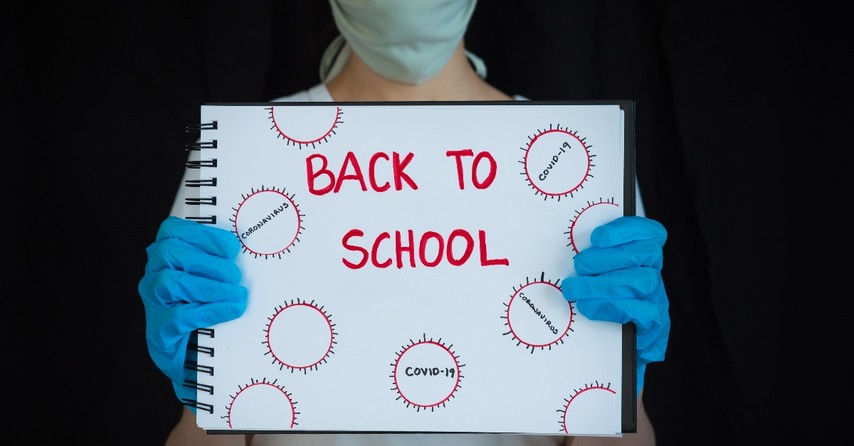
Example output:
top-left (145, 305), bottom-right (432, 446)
top-left (326, 42), bottom-right (511, 102)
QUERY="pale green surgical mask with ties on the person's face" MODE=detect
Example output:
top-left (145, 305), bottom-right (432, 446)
top-left (320, 0), bottom-right (486, 85)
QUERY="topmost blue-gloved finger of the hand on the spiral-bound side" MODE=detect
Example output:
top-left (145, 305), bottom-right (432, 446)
top-left (156, 216), bottom-right (240, 258)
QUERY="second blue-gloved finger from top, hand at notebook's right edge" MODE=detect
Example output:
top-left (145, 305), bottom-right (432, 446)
top-left (573, 240), bottom-right (664, 275)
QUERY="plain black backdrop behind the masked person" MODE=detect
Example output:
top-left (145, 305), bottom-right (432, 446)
top-left (2, 0), bottom-right (852, 445)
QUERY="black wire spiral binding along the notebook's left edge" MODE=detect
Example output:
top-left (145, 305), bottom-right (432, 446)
top-left (182, 121), bottom-right (219, 414)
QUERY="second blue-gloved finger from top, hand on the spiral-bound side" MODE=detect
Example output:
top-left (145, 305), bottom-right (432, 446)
top-left (145, 239), bottom-right (241, 283)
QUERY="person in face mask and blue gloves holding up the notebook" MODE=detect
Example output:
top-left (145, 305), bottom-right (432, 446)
top-left (138, 0), bottom-right (670, 446)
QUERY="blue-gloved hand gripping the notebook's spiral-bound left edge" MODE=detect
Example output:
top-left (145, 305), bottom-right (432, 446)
top-left (138, 217), bottom-right (248, 408)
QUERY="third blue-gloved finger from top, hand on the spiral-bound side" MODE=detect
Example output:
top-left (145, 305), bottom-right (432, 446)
top-left (139, 270), bottom-right (248, 307)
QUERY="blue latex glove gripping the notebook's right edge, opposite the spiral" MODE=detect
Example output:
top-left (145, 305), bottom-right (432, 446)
top-left (561, 216), bottom-right (670, 393)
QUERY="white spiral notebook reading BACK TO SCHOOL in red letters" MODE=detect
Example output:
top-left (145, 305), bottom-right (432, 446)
top-left (185, 101), bottom-right (635, 436)
